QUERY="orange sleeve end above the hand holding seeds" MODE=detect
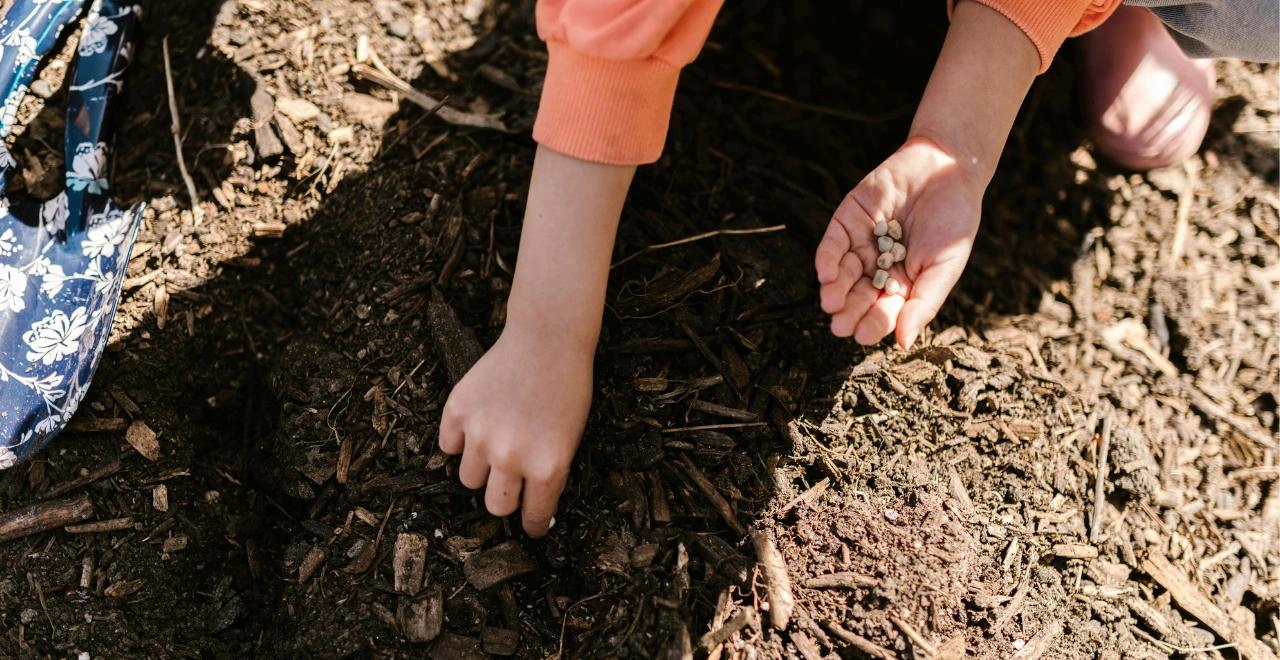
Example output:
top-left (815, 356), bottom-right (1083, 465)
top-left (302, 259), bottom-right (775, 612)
top-left (967, 0), bottom-right (1120, 73)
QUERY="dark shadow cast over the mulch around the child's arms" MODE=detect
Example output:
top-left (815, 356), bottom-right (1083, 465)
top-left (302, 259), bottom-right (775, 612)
top-left (4, 3), bottom-right (1162, 657)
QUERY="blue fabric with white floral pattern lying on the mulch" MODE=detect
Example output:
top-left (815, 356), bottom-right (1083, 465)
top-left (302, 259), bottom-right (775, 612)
top-left (0, 0), bottom-right (142, 469)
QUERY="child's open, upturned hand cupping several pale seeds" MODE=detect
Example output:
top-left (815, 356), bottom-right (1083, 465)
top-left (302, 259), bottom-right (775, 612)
top-left (814, 137), bottom-right (983, 348)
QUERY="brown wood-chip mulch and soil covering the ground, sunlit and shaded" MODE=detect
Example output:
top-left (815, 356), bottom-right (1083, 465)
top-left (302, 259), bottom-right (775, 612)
top-left (0, 0), bottom-right (1280, 659)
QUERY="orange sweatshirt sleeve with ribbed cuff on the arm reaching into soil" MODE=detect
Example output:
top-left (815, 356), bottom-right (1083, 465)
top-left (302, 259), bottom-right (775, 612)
top-left (534, 0), bottom-right (723, 165)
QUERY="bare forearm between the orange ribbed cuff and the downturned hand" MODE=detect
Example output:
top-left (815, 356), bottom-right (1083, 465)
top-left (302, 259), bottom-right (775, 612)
top-left (507, 147), bottom-right (635, 349)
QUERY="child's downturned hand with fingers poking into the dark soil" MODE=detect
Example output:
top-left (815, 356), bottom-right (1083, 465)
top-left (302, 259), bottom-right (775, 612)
top-left (440, 326), bottom-right (594, 536)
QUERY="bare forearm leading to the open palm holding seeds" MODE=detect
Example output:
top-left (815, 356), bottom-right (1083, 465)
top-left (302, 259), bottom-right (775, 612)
top-left (911, 1), bottom-right (1039, 188)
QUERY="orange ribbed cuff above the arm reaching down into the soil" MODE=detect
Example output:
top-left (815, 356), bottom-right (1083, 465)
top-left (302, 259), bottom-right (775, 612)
top-left (534, 41), bottom-right (680, 165)
